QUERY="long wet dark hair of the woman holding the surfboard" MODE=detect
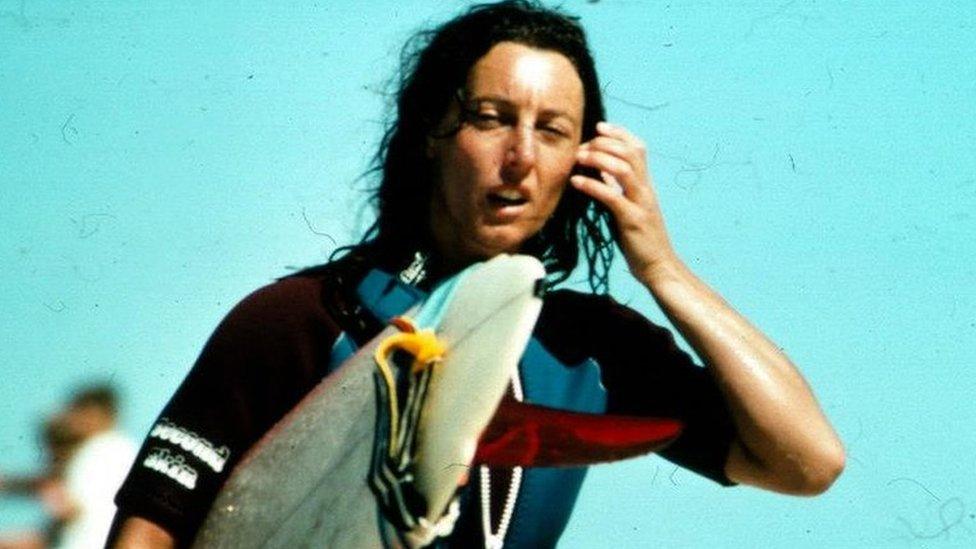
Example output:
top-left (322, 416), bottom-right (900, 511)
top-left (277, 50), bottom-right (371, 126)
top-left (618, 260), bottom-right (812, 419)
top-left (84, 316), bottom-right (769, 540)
top-left (354, 0), bottom-right (613, 292)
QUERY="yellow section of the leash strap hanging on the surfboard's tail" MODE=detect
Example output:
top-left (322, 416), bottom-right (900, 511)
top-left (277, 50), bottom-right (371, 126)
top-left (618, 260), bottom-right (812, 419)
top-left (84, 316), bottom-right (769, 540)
top-left (373, 316), bottom-right (447, 456)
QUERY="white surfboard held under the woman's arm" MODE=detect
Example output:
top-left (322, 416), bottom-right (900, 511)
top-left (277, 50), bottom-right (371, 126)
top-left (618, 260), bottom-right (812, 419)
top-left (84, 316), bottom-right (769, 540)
top-left (194, 256), bottom-right (545, 549)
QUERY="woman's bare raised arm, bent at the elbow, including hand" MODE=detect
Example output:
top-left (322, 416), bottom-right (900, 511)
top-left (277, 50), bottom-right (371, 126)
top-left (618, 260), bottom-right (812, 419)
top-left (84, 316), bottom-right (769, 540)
top-left (571, 122), bottom-right (845, 495)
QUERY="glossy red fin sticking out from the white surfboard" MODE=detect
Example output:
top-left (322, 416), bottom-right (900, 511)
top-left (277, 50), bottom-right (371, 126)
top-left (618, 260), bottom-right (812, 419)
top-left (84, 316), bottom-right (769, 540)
top-left (474, 398), bottom-right (683, 467)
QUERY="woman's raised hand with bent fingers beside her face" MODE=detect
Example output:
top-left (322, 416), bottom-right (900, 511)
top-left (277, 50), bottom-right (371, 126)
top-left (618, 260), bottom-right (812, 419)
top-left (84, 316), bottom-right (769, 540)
top-left (570, 122), bottom-right (677, 285)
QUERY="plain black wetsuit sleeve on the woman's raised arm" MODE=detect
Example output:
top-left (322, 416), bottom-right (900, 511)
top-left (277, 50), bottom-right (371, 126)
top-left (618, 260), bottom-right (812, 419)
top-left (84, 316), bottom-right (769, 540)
top-left (590, 297), bottom-right (734, 486)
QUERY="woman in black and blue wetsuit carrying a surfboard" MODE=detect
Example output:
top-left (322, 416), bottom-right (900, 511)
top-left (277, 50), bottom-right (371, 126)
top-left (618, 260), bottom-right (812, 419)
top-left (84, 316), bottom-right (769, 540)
top-left (105, 1), bottom-right (844, 547)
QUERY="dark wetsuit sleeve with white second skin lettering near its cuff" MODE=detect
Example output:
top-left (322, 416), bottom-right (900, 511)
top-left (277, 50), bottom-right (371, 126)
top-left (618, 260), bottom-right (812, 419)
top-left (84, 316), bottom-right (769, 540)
top-left (116, 278), bottom-right (339, 545)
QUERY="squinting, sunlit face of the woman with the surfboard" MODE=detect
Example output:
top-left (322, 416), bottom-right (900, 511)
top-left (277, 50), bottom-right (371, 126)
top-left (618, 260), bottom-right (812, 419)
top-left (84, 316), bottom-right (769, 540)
top-left (427, 42), bottom-right (583, 264)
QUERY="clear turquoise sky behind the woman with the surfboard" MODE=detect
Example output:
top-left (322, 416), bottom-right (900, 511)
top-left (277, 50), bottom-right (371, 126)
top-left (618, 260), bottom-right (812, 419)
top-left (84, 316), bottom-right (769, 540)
top-left (0, 0), bottom-right (976, 548)
